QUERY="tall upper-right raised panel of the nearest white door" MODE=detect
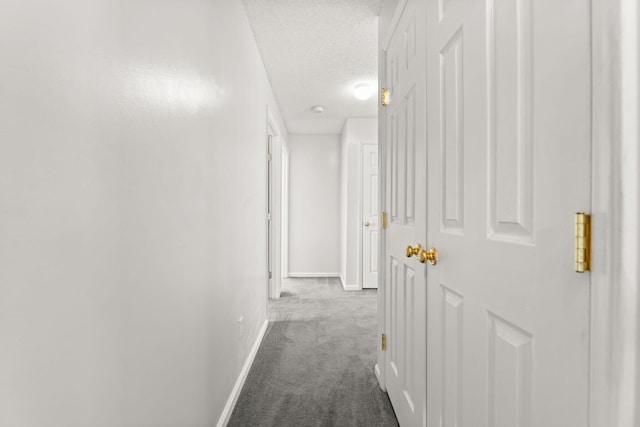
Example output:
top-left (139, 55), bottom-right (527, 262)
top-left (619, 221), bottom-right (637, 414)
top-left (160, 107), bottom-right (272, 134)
top-left (487, 0), bottom-right (534, 243)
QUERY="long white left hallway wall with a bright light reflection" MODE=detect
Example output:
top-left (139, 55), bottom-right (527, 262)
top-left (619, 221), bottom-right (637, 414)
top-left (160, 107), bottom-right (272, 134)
top-left (0, 0), bottom-right (285, 427)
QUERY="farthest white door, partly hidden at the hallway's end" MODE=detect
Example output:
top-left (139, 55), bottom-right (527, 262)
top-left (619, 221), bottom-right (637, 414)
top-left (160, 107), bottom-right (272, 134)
top-left (361, 144), bottom-right (380, 288)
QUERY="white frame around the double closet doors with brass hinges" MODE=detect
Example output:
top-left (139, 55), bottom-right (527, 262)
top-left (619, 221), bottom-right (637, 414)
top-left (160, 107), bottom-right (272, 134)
top-left (375, 0), bottom-right (640, 427)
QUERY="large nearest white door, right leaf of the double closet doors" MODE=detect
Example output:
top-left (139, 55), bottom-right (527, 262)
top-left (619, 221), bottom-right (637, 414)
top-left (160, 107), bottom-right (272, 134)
top-left (426, 0), bottom-right (591, 427)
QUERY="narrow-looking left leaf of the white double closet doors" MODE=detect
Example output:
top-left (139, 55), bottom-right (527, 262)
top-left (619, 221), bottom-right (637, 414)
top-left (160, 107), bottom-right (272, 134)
top-left (384, 0), bottom-right (426, 426)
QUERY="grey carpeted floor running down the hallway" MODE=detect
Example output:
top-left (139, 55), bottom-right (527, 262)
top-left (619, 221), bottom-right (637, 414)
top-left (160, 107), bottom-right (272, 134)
top-left (228, 278), bottom-right (398, 427)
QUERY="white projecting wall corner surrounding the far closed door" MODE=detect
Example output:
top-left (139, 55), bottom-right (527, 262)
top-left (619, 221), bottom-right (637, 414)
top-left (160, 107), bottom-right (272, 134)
top-left (340, 117), bottom-right (378, 289)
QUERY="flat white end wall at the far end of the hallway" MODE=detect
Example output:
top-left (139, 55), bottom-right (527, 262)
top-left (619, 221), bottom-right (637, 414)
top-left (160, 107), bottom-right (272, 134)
top-left (288, 134), bottom-right (340, 276)
